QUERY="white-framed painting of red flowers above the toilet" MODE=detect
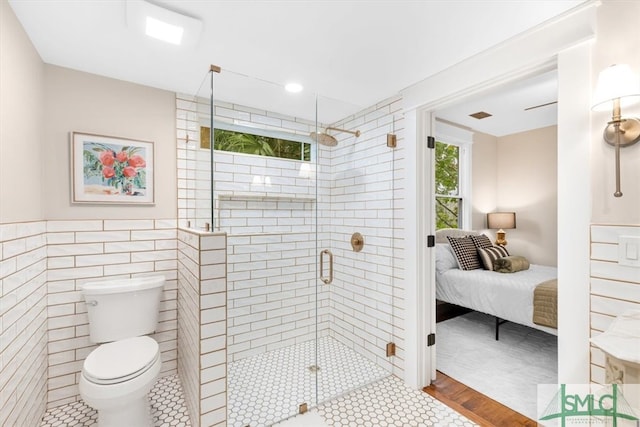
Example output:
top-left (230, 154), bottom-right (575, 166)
top-left (71, 132), bottom-right (154, 204)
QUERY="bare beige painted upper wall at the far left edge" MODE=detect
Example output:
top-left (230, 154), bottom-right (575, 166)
top-left (0, 0), bottom-right (44, 223)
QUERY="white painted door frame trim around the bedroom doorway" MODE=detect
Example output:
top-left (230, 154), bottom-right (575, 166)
top-left (403, 2), bottom-right (598, 418)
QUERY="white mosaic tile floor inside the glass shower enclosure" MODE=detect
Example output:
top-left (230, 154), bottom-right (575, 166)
top-left (227, 337), bottom-right (389, 427)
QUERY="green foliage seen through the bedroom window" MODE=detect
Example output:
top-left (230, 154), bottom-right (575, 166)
top-left (435, 141), bottom-right (462, 230)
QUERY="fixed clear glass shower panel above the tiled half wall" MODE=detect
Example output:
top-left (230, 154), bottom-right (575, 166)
top-left (212, 70), bottom-right (318, 427)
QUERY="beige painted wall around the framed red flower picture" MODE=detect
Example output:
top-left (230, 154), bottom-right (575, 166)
top-left (43, 64), bottom-right (177, 219)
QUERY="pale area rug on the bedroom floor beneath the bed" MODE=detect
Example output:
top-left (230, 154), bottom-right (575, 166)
top-left (436, 312), bottom-right (558, 420)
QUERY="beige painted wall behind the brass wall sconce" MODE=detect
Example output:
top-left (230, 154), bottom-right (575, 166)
top-left (591, 0), bottom-right (640, 224)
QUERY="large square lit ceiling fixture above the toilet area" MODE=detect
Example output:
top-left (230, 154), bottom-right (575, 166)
top-left (126, 0), bottom-right (202, 46)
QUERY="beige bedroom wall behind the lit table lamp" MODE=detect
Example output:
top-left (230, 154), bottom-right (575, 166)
top-left (472, 126), bottom-right (558, 266)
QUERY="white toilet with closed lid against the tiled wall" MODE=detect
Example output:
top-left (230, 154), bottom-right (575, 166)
top-left (79, 276), bottom-right (165, 427)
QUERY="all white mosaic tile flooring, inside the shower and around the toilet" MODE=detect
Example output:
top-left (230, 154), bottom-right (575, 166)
top-left (41, 337), bottom-right (475, 427)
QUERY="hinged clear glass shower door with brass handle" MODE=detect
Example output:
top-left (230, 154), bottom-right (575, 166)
top-left (314, 96), bottom-right (402, 410)
